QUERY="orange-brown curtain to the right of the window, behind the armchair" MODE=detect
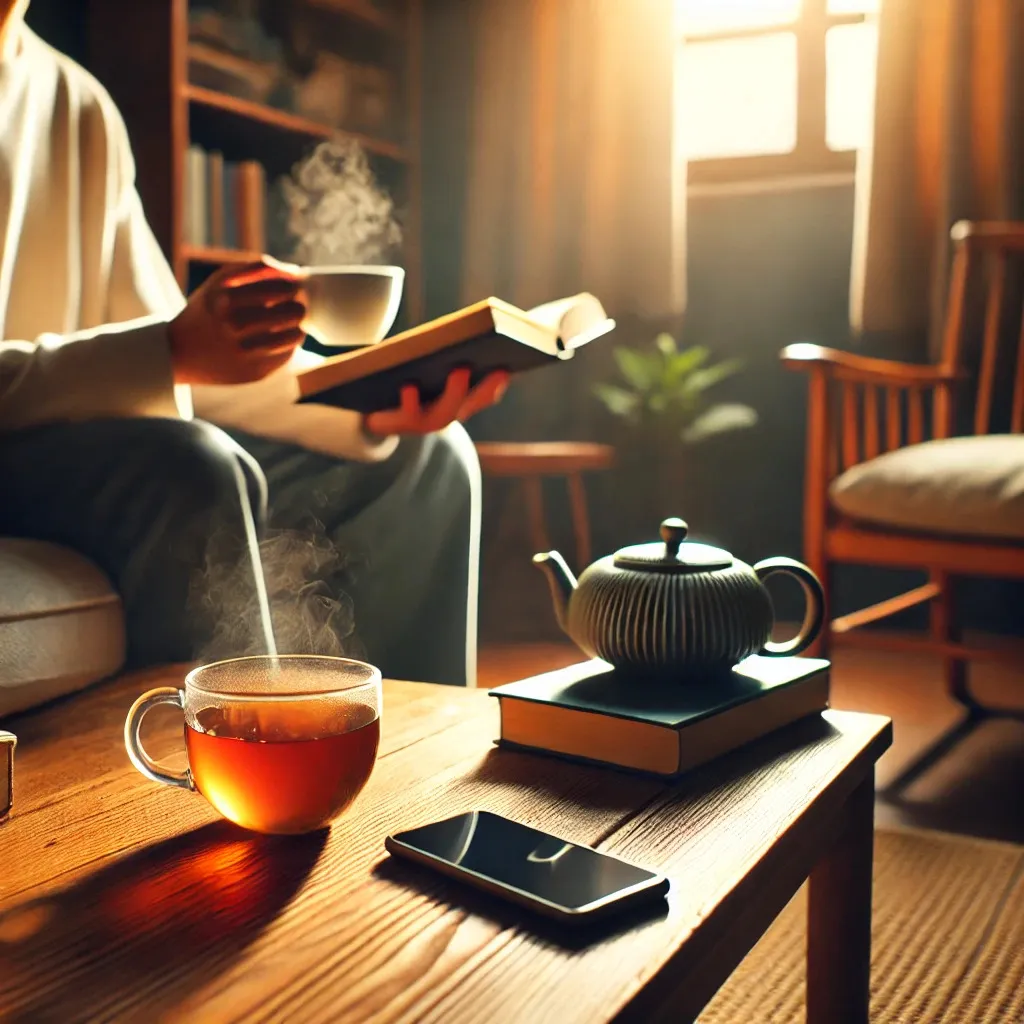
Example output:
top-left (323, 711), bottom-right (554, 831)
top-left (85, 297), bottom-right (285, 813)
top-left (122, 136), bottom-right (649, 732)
top-left (851, 0), bottom-right (1024, 358)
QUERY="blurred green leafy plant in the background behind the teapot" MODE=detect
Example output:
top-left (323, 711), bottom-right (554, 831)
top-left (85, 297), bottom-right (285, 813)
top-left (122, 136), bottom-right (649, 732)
top-left (594, 334), bottom-right (758, 530)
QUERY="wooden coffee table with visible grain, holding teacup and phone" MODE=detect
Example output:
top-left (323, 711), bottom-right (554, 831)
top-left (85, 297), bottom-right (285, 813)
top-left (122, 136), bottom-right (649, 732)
top-left (0, 671), bottom-right (891, 1024)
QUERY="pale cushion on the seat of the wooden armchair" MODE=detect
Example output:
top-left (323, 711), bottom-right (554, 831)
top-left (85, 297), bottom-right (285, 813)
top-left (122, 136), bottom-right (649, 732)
top-left (830, 434), bottom-right (1024, 540)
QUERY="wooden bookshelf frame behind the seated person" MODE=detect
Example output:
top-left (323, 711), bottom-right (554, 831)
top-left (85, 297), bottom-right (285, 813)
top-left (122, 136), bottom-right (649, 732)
top-left (88, 0), bottom-right (423, 326)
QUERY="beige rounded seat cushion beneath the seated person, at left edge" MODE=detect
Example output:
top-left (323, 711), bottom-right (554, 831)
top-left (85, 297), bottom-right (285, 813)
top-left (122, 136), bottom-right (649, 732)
top-left (0, 538), bottom-right (125, 716)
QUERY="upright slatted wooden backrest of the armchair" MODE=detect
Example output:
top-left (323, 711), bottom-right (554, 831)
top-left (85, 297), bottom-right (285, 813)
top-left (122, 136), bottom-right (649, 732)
top-left (934, 220), bottom-right (1024, 437)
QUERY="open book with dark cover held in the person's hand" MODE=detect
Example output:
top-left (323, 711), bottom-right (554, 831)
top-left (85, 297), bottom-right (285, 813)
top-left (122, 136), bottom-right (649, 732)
top-left (298, 292), bottom-right (615, 414)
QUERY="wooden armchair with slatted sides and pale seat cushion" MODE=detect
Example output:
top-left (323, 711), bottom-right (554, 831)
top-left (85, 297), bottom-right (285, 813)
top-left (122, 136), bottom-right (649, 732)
top-left (781, 222), bottom-right (1024, 795)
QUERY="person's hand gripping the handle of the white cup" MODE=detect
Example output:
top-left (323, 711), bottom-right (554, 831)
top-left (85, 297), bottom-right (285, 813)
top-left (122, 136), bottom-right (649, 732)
top-left (168, 257), bottom-right (306, 384)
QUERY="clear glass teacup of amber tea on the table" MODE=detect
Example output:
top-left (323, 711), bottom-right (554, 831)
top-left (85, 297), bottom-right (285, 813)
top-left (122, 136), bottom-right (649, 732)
top-left (125, 655), bottom-right (381, 833)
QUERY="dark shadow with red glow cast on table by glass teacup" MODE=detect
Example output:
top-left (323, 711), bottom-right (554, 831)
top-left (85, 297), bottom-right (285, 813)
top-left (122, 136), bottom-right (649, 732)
top-left (0, 821), bottom-right (328, 1021)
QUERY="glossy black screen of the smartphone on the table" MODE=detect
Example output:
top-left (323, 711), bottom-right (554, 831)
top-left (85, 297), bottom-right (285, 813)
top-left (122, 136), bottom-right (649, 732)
top-left (385, 811), bottom-right (668, 910)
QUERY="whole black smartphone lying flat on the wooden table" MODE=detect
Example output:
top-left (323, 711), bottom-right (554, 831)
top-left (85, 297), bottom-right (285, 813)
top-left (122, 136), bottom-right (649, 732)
top-left (384, 811), bottom-right (669, 924)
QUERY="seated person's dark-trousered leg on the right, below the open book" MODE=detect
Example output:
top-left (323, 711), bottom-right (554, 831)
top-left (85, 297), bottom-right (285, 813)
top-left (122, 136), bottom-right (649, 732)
top-left (224, 425), bottom-right (480, 685)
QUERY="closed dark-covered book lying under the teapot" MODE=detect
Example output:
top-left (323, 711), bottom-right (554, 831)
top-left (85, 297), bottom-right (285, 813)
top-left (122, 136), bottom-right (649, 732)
top-left (490, 655), bottom-right (829, 778)
